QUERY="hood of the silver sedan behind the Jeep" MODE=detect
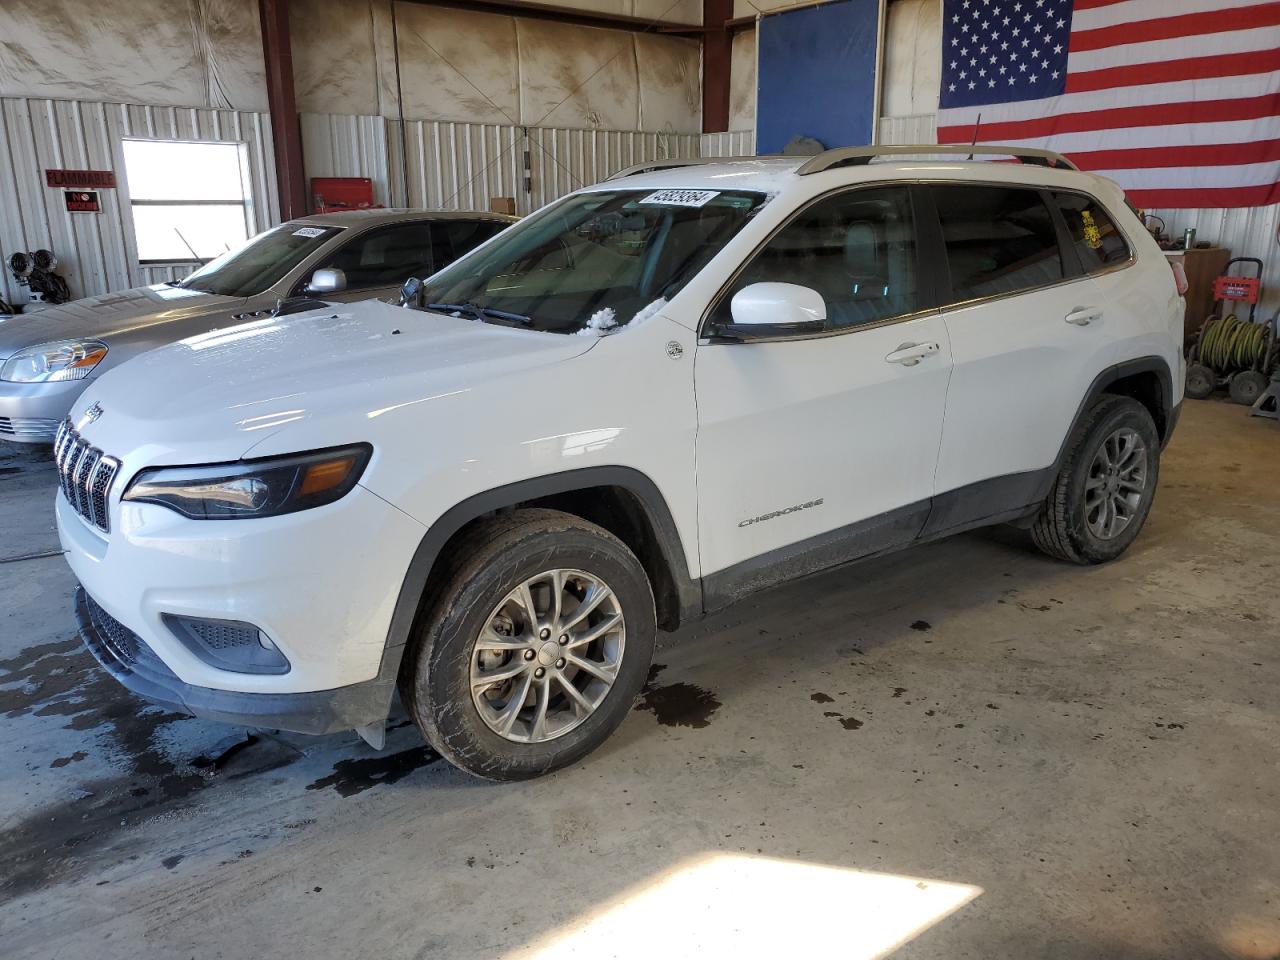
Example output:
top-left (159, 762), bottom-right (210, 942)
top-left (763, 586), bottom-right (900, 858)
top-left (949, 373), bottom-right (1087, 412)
top-left (0, 284), bottom-right (242, 358)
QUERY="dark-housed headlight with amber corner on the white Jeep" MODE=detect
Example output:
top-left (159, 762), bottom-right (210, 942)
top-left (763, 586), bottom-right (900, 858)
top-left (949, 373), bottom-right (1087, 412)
top-left (123, 443), bottom-right (372, 520)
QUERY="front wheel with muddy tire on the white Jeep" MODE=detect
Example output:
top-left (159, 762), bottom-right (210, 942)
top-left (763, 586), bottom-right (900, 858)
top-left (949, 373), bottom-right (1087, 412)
top-left (401, 509), bottom-right (657, 780)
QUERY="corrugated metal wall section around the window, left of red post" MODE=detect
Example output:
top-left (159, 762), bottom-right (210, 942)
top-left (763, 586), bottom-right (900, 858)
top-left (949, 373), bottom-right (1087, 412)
top-left (0, 99), bottom-right (279, 302)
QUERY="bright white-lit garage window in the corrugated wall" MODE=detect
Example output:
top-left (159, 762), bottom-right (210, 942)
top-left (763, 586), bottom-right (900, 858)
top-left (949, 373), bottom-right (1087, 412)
top-left (123, 140), bottom-right (251, 264)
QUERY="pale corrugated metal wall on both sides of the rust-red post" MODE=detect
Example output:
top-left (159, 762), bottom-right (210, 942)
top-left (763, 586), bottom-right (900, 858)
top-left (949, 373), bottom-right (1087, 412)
top-left (0, 99), bottom-right (701, 303)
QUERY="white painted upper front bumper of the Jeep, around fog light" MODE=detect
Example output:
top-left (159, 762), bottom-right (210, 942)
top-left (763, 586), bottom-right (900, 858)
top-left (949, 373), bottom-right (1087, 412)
top-left (55, 478), bottom-right (424, 695)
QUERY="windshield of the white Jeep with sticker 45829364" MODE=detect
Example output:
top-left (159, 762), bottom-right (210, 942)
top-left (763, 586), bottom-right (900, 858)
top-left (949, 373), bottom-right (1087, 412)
top-left (420, 189), bottom-right (765, 334)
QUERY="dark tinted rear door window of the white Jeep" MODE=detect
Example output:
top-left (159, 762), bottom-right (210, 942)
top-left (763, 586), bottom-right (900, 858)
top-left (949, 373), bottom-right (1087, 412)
top-left (932, 184), bottom-right (1065, 302)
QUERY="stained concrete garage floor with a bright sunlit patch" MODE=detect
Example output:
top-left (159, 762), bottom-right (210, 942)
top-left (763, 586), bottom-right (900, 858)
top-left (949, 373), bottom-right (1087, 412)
top-left (0, 402), bottom-right (1280, 960)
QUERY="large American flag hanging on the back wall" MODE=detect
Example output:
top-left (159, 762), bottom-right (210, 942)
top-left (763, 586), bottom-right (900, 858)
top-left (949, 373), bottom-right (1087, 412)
top-left (938, 0), bottom-right (1280, 209)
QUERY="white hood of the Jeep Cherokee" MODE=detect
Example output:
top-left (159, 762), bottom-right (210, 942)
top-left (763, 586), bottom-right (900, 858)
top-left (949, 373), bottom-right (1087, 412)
top-left (72, 301), bottom-right (596, 466)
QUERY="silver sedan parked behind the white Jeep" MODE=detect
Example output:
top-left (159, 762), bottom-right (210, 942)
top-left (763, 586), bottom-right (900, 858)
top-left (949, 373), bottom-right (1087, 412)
top-left (0, 210), bottom-right (516, 443)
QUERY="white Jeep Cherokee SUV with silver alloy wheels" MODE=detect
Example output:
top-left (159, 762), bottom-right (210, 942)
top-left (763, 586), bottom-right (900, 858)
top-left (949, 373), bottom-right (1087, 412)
top-left (56, 146), bottom-right (1183, 780)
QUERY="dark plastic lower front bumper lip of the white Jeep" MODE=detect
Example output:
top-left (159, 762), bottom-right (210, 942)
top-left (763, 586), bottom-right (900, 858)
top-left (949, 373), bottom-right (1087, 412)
top-left (76, 588), bottom-right (396, 733)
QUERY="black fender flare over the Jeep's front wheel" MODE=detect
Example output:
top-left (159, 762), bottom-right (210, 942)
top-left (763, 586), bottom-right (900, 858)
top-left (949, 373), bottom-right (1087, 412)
top-left (379, 466), bottom-right (703, 701)
